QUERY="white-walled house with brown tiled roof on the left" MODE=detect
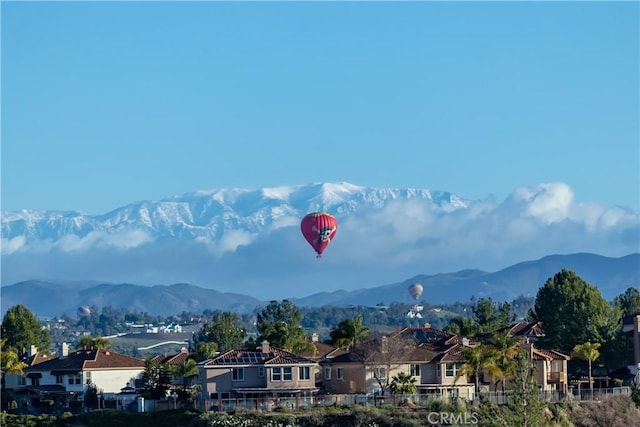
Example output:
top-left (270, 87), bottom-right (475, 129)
top-left (16, 344), bottom-right (144, 408)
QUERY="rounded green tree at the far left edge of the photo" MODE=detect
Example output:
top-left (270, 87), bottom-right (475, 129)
top-left (0, 304), bottom-right (51, 354)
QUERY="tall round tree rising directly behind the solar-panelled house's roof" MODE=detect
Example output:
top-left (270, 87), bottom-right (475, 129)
top-left (256, 300), bottom-right (305, 351)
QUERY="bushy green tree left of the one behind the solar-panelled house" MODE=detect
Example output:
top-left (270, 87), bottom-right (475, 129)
top-left (195, 310), bottom-right (247, 352)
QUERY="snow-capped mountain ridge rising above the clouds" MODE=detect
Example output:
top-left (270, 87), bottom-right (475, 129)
top-left (2, 183), bottom-right (468, 244)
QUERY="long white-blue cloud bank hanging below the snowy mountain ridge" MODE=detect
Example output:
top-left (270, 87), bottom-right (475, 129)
top-left (2, 183), bottom-right (640, 299)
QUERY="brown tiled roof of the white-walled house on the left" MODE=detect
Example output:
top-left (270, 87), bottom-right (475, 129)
top-left (24, 349), bottom-right (144, 373)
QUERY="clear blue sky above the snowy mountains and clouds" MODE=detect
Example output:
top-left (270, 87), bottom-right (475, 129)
top-left (1, 2), bottom-right (640, 214)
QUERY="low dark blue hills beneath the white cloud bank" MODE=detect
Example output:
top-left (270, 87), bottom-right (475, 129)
top-left (0, 253), bottom-right (640, 317)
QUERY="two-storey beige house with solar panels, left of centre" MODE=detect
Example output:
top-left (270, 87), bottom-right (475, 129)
top-left (198, 341), bottom-right (318, 400)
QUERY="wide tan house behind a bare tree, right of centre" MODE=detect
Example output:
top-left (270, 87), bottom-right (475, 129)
top-left (322, 325), bottom-right (474, 399)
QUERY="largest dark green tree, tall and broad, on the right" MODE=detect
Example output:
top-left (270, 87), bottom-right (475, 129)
top-left (530, 269), bottom-right (618, 352)
